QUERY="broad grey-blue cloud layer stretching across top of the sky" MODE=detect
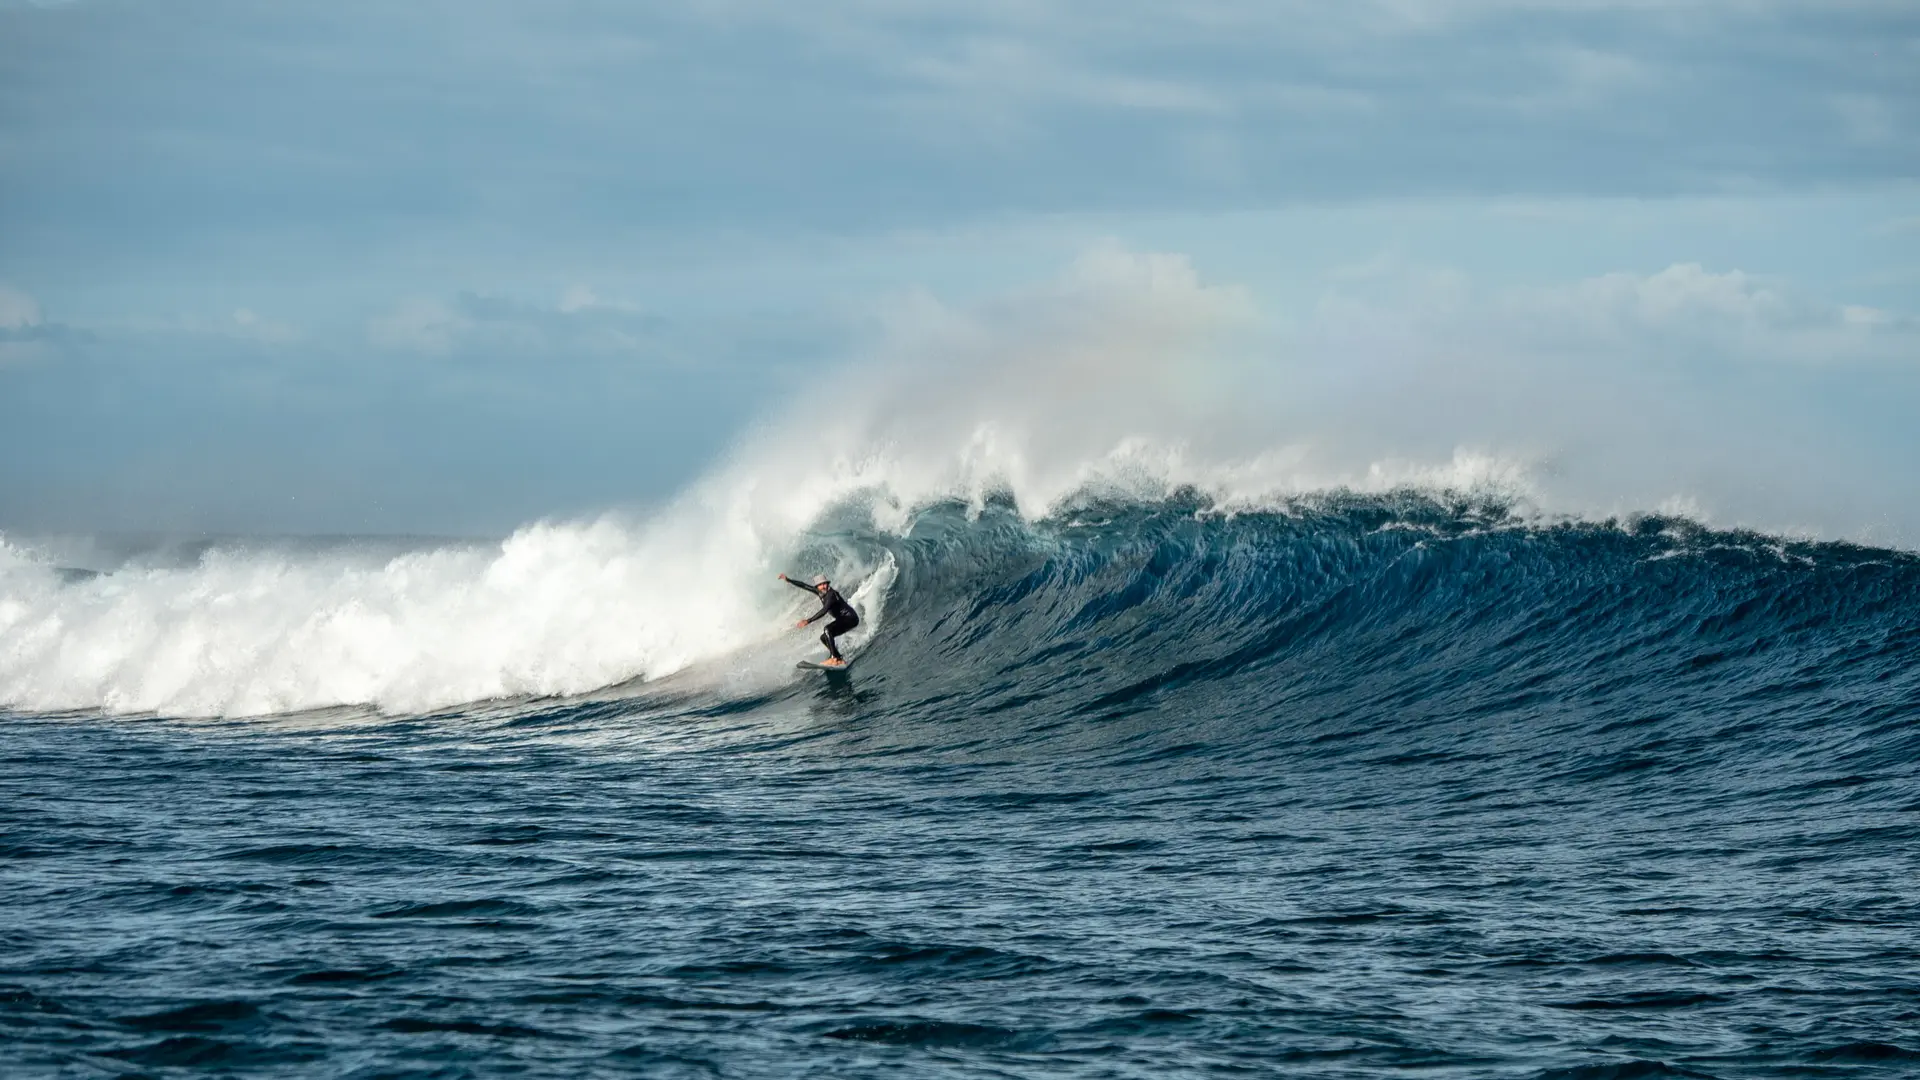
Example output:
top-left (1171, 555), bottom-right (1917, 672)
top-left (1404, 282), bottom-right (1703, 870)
top-left (11, 0), bottom-right (1920, 267)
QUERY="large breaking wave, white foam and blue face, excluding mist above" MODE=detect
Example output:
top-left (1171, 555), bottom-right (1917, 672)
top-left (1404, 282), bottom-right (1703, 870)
top-left (0, 488), bottom-right (1920, 730)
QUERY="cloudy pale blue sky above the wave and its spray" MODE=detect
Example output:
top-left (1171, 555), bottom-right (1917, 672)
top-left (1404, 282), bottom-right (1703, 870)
top-left (0, 0), bottom-right (1920, 540)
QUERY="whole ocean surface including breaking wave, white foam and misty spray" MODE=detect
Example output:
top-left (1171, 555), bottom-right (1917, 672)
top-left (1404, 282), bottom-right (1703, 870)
top-left (0, 252), bottom-right (1920, 1080)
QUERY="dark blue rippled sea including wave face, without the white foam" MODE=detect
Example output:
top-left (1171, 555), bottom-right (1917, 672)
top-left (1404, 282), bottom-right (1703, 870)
top-left (0, 498), bottom-right (1920, 1080)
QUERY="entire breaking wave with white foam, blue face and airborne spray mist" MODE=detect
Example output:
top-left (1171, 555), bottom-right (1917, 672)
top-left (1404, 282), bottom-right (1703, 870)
top-left (0, 252), bottom-right (1914, 715)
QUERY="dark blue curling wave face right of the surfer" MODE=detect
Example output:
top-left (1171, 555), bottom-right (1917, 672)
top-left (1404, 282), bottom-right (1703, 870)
top-left (848, 494), bottom-right (1920, 753)
